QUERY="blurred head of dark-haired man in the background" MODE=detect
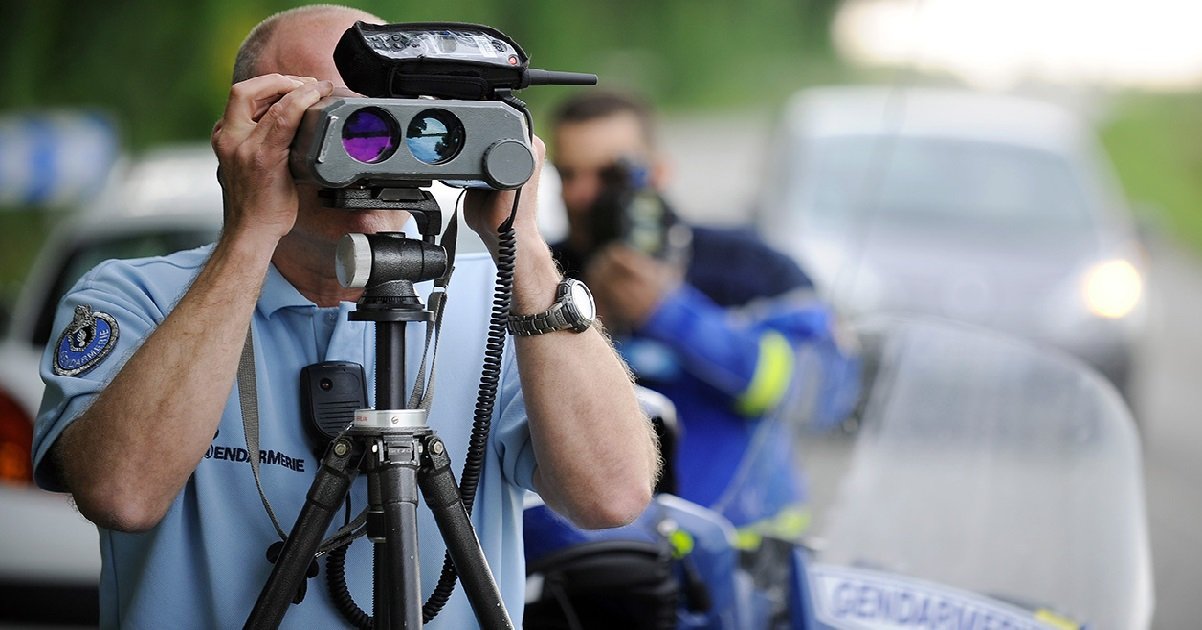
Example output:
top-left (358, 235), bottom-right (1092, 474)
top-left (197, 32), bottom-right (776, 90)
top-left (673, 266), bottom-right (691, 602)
top-left (551, 91), bottom-right (667, 251)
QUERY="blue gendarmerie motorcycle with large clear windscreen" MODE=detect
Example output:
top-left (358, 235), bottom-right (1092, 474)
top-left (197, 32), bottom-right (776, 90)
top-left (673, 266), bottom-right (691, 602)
top-left (526, 317), bottom-right (1153, 630)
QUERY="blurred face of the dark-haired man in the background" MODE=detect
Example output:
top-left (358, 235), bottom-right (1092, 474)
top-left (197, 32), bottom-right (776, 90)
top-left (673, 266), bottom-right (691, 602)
top-left (553, 113), bottom-right (660, 251)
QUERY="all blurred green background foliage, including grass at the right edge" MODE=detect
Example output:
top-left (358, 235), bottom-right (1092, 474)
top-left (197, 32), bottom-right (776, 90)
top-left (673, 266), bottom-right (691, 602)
top-left (0, 0), bottom-right (1202, 303)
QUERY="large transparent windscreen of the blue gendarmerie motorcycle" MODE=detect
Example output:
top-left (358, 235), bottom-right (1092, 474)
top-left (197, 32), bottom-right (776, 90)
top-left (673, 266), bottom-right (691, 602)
top-left (815, 319), bottom-right (1153, 630)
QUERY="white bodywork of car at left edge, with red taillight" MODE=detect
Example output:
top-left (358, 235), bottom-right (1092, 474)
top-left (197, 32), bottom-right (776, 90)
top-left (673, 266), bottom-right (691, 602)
top-left (0, 147), bottom-right (221, 625)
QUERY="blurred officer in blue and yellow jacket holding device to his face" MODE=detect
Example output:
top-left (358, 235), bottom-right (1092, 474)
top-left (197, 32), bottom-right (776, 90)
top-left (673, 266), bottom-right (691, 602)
top-left (552, 91), bottom-right (855, 549)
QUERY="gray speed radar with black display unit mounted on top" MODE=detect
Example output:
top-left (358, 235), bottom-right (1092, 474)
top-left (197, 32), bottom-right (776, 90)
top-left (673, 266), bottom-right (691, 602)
top-left (290, 22), bottom-right (596, 190)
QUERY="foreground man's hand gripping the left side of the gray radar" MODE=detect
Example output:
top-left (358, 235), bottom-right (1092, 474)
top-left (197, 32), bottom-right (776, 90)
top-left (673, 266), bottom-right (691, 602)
top-left (212, 75), bottom-right (333, 242)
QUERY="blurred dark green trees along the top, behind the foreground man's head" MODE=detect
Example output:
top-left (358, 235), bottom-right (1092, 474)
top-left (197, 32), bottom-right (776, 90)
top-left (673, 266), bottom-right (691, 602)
top-left (0, 0), bottom-right (839, 148)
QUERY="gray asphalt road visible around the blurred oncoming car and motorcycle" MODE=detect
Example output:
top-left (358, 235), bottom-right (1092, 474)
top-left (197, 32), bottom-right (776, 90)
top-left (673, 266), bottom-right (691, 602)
top-left (661, 113), bottom-right (1202, 630)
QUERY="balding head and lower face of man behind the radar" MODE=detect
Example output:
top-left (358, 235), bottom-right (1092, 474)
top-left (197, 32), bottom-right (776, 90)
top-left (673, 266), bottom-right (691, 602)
top-left (257, 11), bottom-right (409, 243)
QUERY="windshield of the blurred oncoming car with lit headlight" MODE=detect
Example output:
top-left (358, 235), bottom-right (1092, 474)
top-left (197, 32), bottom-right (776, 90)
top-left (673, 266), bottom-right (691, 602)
top-left (793, 136), bottom-right (1089, 232)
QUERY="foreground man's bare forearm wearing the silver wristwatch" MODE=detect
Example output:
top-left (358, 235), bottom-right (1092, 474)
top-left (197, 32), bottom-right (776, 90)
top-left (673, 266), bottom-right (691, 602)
top-left (514, 240), bottom-right (659, 528)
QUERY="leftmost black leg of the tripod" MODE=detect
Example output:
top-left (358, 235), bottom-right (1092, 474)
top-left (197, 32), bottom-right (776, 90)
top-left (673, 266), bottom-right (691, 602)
top-left (244, 440), bottom-right (362, 629)
